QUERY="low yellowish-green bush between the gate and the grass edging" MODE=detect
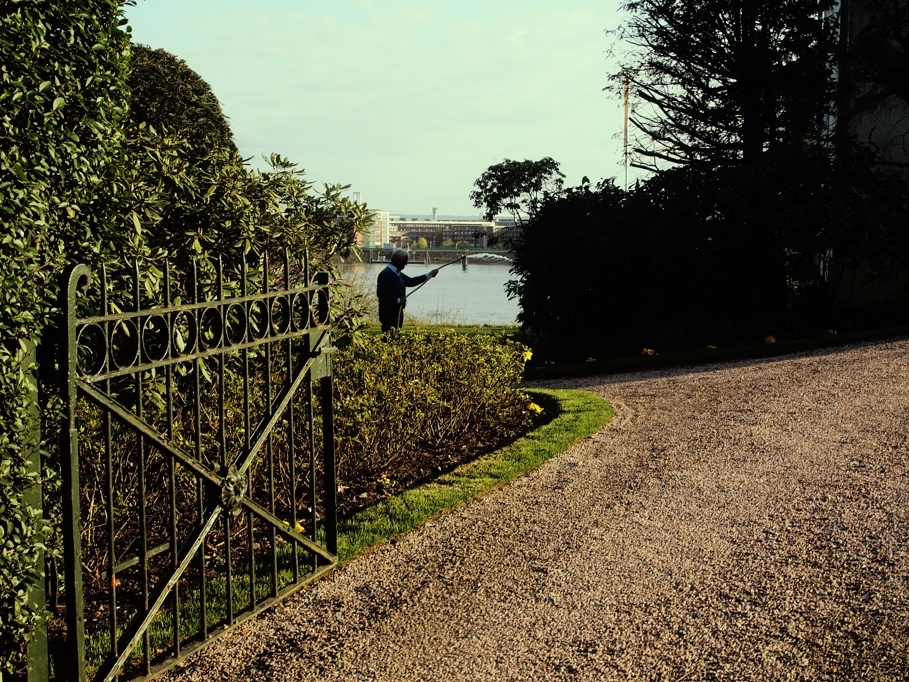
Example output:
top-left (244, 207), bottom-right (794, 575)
top-left (334, 329), bottom-right (530, 482)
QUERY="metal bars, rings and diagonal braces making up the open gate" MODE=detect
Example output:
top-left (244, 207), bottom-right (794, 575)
top-left (58, 252), bottom-right (337, 680)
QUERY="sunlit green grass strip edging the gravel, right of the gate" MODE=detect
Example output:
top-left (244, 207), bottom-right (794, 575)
top-left (338, 389), bottom-right (613, 564)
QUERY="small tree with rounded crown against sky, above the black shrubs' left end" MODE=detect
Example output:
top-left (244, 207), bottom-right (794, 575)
top-left (470, 156), bottom-right (565, 225)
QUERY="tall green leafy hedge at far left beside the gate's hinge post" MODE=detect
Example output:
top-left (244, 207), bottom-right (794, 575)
top-left (0, 0), bottom-right (129, 672)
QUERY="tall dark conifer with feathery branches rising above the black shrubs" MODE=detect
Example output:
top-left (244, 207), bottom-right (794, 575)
top-left (611, 0), bottom-right (836, 170)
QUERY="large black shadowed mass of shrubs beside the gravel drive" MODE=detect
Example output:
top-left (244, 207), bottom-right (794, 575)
top-left (509, 150), bottom-right (909, 359)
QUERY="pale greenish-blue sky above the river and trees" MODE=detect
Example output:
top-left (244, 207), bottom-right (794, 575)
top-left (125, 0), bottom-right (636, 216)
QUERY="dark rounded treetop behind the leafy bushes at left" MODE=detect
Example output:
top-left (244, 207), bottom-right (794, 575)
top-left (129, 44), bottom-right (236, 151)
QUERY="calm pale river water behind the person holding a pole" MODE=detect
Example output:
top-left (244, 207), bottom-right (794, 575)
top-left (344, 260), bottom-right (518, 325)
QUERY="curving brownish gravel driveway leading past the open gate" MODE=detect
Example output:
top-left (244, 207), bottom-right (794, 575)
top-left (168, 340), bottom-right (909, 680)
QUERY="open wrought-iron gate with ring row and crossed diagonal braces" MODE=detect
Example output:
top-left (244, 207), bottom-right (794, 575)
top-left (57, 254), bottom-right (337, 681)
